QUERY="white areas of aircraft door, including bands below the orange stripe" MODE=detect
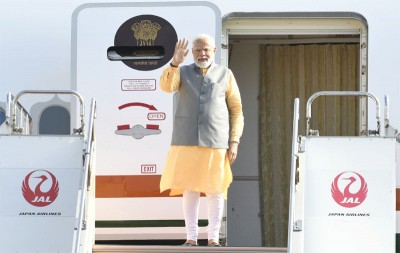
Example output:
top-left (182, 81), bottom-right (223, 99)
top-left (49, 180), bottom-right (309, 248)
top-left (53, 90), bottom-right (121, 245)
top-left (72, 2), bottom-right (225, 240)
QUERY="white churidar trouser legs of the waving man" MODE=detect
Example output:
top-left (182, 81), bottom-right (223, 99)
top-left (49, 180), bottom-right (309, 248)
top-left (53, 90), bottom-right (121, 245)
top-left (183, 190), bottom-right (224, 242)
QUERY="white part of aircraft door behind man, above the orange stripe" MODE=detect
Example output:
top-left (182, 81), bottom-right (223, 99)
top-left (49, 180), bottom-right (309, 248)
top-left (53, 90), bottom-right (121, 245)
top-left (72, 3), bottom-right (220, 178)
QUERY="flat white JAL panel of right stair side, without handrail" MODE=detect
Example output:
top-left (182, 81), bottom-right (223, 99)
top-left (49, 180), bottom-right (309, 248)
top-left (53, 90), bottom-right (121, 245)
top-left (299, 137), bottom-right (396, 253)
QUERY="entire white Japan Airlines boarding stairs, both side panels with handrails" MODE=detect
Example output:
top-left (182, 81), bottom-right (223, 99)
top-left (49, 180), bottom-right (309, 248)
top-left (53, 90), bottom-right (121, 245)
top-left (0, 91), bottom-right (398, 253)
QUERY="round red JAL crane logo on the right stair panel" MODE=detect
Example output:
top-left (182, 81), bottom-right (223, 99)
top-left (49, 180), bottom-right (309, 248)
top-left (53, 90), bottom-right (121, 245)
top-left (331, 171), bottom-right (368, 208)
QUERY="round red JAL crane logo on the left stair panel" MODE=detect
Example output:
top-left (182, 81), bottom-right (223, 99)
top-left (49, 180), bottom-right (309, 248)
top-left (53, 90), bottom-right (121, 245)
top-left (22, 170), bottom-right (59, 207)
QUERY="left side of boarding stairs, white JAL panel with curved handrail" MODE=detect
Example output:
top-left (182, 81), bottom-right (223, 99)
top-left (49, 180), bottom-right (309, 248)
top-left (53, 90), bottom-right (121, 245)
top-left (0, 91), bottom-right (96, 253)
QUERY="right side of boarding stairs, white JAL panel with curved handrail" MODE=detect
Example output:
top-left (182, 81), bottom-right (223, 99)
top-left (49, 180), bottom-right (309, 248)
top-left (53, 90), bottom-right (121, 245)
top-left (288, 91), bottom-right (399, 253)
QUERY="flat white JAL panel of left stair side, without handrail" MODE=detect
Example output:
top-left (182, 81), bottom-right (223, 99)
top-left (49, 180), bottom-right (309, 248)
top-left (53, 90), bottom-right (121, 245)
top-left (0, 135), bottom-right (84, 253)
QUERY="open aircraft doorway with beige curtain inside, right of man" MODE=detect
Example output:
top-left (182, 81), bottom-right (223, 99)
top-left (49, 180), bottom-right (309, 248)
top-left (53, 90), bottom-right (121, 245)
top-left (223, 13), bottom-right (367, 247)
